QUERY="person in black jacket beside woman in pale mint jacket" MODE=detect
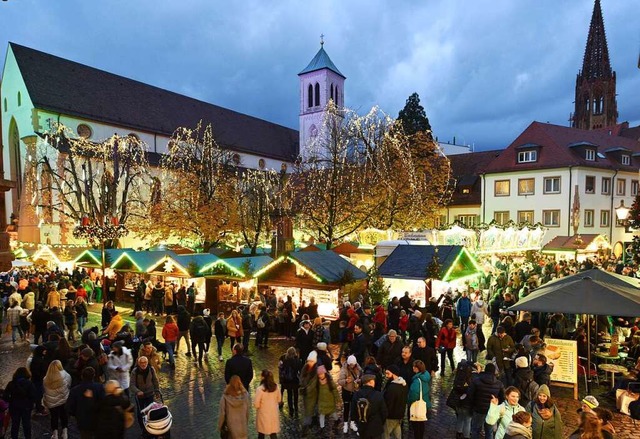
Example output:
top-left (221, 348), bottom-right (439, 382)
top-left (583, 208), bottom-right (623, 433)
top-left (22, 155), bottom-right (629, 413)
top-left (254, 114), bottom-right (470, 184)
top-left (467, 363), bottom-right (504, 439)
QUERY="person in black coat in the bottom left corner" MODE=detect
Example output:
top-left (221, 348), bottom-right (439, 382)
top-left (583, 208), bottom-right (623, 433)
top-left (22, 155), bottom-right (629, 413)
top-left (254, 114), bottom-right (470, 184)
top-left (2, 367), bottom-right (36, 439)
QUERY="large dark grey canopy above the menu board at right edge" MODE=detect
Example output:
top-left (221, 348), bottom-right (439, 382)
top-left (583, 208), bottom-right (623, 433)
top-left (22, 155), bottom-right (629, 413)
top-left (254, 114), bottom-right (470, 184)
top-left (509, 268), bottom-right (640, 316)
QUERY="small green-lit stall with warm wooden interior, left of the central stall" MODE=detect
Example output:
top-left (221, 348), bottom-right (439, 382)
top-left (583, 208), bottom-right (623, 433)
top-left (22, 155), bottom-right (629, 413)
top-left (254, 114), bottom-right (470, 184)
top-left (200, 255), bottom-right (273, 314)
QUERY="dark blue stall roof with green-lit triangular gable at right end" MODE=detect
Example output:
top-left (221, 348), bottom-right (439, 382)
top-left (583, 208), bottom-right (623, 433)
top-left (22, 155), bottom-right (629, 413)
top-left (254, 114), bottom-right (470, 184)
top-left (378, 245), bottom-right (481, 282)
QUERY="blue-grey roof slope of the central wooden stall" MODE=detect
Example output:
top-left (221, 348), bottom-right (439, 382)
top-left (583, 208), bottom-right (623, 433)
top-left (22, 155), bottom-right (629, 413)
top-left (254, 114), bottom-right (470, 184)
top-left (289, 250), bottom-right (367, 283)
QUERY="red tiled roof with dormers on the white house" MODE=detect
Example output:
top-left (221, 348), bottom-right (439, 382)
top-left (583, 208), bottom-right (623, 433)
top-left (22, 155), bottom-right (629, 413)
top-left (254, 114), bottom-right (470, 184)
top-left (485, 122), bottom-right (640, 174)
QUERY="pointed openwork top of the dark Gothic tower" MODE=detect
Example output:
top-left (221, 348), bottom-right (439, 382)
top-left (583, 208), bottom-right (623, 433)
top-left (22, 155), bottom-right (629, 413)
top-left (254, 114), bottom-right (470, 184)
top-left (581, 0), bottom-right (613, 80)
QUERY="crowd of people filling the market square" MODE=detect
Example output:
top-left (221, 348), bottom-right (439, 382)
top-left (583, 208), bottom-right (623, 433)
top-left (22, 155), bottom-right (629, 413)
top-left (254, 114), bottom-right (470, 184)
top-left (0, 254), bottom-right (640, 439)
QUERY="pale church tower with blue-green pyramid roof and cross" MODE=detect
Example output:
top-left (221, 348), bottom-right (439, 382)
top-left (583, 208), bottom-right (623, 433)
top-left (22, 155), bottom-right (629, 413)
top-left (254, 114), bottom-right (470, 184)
top-left (298, 35), bottom-right (347, 155)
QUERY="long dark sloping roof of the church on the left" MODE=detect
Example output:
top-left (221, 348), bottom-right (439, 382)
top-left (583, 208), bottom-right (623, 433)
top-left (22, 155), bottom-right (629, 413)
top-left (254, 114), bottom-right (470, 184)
top-left (9, 43), bottom-right (299, 161)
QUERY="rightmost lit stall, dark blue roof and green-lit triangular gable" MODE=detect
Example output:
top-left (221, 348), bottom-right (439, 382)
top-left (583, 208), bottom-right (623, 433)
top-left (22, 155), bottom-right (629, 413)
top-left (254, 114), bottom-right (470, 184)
top-left (378, 245), bottom-right (482, 306)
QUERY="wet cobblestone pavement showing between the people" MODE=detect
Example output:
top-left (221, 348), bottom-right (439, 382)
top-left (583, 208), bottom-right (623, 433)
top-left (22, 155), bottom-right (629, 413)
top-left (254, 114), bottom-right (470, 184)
top-left (0, 310), bottom-right (640, 439)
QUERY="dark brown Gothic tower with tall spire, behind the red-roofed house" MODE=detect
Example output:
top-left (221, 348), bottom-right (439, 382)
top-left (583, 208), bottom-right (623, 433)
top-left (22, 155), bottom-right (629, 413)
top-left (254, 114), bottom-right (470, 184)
top-left (572, 0), bottom-right (618, 130)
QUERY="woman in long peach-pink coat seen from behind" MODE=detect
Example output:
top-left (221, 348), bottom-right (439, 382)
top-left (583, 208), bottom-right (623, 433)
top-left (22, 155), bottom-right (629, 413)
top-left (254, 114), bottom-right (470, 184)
top-left (253, 369), bottom-right (281, 439)
